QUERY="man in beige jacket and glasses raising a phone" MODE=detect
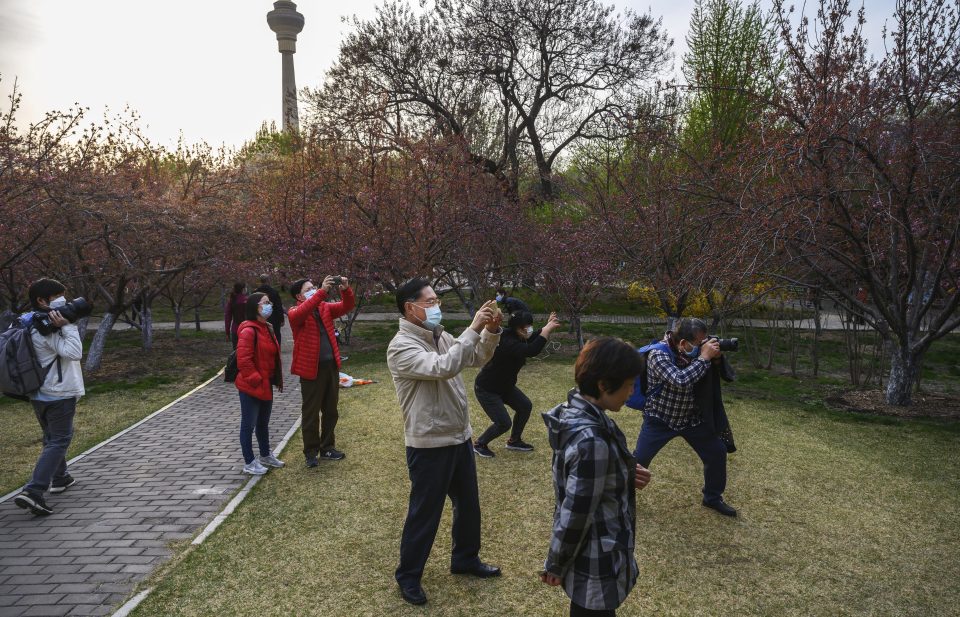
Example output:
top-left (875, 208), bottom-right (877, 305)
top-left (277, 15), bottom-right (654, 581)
top-left (387, 278), bottom-right (502, 604)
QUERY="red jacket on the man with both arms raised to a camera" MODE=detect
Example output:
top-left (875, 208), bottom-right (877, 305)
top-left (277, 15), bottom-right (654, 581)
top-left (287, 287), bottom-right (354, 379)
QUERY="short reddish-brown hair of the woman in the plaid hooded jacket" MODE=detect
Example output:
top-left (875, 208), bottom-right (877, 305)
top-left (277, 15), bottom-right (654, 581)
top-left (573, 336), bottom-right (643, 396)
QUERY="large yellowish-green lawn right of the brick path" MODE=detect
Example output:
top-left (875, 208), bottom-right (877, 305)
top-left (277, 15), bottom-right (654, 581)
top-left (129, 326), bottom-right (960, 617)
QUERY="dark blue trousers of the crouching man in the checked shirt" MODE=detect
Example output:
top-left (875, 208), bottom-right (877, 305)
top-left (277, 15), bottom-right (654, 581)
top-left (633, 416), bottom-right (727, 503)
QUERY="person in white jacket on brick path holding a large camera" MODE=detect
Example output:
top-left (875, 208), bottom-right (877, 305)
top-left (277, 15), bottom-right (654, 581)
top-left (13, 279), bottom-right (90, 515)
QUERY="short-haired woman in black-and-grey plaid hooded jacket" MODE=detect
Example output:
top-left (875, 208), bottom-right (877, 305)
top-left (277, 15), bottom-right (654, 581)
top-left (540, 337), bottom-right (650, 617)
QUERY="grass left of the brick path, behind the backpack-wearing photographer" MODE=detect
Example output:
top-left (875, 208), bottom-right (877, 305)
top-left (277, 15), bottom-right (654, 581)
top-left (0, 330), bottom-right (230, 494)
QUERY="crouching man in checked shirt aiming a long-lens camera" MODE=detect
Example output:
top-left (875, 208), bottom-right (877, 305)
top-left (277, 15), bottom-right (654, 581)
top-left (633, 318), bottom-right (737, 516)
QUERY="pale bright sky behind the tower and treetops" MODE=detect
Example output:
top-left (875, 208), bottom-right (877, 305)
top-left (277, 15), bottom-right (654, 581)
top-left (0, 0), bottom-right (894, 146)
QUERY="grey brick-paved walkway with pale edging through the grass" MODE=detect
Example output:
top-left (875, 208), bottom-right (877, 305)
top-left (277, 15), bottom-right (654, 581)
top-left (0, 330), bottom-right (300, 616)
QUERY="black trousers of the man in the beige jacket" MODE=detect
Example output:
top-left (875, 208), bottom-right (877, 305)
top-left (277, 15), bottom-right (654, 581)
top-left (396, 441), bottom-right (480, 587)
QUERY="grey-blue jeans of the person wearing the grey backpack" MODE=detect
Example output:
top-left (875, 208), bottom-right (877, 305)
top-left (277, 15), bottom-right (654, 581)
top-left (24, 398), bottom-right (77, 497)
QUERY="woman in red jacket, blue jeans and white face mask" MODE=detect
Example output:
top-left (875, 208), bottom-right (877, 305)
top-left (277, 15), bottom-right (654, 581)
top-left (234, 293), bottom-right (283, 475)
